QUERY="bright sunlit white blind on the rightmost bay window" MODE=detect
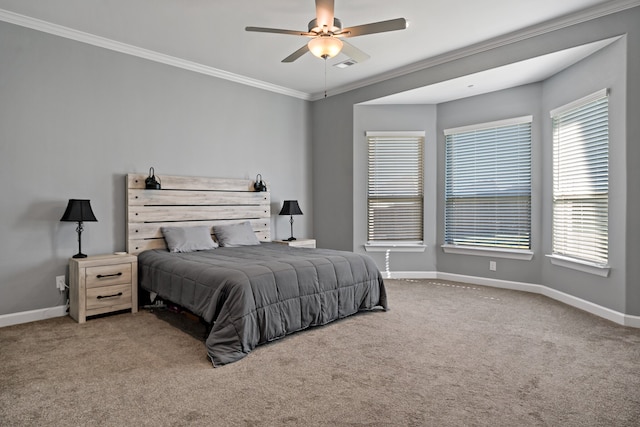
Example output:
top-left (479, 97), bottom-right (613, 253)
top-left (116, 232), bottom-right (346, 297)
top-left (551, 90), bottom-right (609, 265)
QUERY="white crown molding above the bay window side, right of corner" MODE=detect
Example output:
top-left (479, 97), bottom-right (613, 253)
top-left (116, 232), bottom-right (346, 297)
top-left (311, 0), bottom-right (640, 101)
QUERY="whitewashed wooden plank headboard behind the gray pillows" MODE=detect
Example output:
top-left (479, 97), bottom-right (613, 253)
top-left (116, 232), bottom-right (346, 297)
top-left (127, 174), bottom-right (271, 254)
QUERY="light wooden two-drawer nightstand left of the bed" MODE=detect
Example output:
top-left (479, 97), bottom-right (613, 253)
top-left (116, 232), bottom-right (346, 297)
top-left (69, 254), bottom-right (138, 323)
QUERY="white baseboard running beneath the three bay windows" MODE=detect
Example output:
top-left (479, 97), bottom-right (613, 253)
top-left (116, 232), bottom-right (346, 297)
top-left (383, 271), bottom-right (640, 328)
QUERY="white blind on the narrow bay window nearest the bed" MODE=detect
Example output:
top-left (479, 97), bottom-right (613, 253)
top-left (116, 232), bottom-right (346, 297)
top-left (366, 132), bottom-right (424, 243)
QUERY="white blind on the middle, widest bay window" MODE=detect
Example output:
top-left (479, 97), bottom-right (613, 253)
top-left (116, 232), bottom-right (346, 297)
top-left (445, 116), bottom-right (533, 250)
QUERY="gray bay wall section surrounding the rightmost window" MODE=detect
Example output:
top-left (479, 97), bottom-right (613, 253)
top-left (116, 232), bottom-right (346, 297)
top-left (541, 38), bottom-right (640, 314)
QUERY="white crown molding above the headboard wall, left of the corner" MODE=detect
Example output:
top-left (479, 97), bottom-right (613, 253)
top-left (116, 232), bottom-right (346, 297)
top-left (0, 9), bottom-right (311, 100)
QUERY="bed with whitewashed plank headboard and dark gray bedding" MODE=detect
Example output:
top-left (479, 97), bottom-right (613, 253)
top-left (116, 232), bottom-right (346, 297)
top-left (127, 174), bottom-right (387, 366)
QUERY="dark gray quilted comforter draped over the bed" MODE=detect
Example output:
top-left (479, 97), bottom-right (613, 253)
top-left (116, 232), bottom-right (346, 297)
top-left (138, 243), bottom-right (387, 366)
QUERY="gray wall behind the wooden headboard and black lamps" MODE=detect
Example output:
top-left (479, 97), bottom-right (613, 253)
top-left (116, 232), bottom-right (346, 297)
top-left (0, 22), bottom-right (313, 315)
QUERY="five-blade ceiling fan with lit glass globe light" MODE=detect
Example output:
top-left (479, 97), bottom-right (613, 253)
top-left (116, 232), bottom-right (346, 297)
top-left (245, 0), bottom-right (407, 62)
